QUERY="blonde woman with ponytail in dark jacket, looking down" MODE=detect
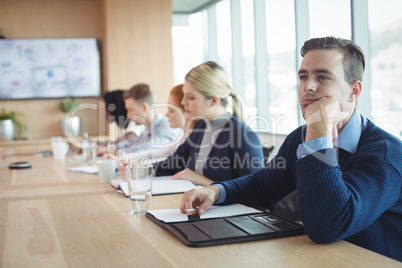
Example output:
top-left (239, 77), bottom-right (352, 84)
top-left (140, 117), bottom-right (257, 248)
top-left (155, 62), bottom-right (263, 186)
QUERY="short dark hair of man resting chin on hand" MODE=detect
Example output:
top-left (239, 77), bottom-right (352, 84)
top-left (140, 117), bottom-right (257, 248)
top-left (300, 36), bottom-right (365, 85)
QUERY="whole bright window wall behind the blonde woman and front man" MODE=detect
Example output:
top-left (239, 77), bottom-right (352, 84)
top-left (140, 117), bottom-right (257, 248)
top-left (172, 0), bottom-right (402, 138)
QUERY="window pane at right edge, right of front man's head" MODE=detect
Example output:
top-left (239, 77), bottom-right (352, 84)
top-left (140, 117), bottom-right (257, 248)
top-left (366, 0), bottom-right (402, 138)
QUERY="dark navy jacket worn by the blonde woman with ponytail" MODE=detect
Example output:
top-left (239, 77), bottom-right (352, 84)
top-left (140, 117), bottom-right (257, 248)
top-left (155, 116), bottom-right (264, 181)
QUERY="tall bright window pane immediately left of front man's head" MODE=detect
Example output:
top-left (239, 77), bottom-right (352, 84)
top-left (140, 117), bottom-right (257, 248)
top-left (265, 0), bottom-right (298, 133)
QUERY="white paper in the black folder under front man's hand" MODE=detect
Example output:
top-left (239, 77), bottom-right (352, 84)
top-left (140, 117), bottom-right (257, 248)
top-left (148, 204), bottom-right (261, 223)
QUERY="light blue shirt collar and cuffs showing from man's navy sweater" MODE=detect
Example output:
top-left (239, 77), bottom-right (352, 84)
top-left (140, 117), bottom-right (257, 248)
top-left (215, 108), bottom-right (367, 204)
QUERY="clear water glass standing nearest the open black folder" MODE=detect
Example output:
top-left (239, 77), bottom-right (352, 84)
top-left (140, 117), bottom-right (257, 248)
top-left (126, 162), bottom-right (153, 214)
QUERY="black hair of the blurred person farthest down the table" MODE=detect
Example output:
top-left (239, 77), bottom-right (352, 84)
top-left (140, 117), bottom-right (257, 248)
top-left (103, 90), bottom-right (129, 128)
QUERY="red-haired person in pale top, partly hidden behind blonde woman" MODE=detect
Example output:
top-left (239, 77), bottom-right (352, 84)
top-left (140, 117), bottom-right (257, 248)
top-left (125, 84), bottom-right (196, 161)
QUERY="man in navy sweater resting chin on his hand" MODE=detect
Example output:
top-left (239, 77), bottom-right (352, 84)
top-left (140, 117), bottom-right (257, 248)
top-left (180, 37), bottom-right (402, 261)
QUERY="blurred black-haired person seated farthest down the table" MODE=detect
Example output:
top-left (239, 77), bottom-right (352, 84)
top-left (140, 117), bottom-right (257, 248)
top-left (103, 90), bottom-right (142, 142)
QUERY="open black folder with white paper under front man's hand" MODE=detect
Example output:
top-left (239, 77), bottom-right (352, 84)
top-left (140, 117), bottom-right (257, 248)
top-left (145, 204), bottom-right (304, 247)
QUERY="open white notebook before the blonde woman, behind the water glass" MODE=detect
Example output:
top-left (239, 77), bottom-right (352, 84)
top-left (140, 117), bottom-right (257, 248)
top-left (111, 176), bottom-right (197, 197)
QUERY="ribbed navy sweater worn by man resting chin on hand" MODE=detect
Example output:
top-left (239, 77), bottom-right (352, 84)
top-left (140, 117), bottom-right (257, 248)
top-left (220, 121), bottom-right (402, 261)
